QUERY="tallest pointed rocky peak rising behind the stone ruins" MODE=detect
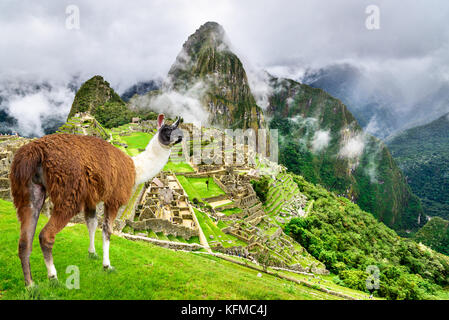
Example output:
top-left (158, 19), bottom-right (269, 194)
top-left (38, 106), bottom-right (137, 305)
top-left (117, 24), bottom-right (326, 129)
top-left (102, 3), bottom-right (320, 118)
top-left (168, 22), bottom-right (265, 129)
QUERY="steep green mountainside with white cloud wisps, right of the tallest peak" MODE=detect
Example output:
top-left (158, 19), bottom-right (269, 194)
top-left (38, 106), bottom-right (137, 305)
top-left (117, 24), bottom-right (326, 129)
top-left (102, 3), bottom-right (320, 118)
top-left (266, 77), bottom-right (422, 230)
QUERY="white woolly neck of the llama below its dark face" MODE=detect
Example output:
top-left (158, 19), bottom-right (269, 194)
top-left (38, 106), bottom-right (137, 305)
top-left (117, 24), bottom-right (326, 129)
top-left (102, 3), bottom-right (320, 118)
top-left (132, 133), bottom-right (171, 185)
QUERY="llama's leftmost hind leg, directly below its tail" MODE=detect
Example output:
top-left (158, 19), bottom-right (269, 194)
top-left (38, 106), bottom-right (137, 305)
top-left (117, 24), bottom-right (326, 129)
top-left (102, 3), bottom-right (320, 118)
top-left (17, 183), bottom-right (45, 286)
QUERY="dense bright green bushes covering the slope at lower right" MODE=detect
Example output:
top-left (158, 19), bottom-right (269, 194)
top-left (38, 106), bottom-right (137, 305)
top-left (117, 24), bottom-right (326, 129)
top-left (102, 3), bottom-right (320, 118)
top-left (285, 176), bottom-right (449, 299)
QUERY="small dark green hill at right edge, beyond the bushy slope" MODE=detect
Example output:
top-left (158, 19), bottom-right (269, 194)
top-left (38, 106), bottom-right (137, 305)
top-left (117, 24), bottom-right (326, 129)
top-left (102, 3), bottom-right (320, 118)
top-left (413, 217), bottom-right (449, 255)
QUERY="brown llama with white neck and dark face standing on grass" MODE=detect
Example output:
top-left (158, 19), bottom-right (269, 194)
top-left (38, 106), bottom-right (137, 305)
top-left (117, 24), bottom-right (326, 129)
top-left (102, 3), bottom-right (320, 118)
top-left (10, 114), bottom-right (183, 286)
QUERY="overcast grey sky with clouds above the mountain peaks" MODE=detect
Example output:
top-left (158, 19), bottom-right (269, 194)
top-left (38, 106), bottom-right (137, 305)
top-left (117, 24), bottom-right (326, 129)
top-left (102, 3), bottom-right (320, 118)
top-left (0, 0), bottom-right (449, 91)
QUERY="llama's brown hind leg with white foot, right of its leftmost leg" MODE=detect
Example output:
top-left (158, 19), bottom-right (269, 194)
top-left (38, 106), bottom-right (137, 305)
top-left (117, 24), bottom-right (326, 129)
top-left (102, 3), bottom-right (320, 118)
top-left (39, 208), bottom-right (76, 279)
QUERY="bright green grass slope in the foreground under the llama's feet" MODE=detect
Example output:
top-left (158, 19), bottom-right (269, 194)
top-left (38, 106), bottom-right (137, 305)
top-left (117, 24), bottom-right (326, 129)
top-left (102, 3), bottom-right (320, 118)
top-left (0, 200), bottom-right (346, 300)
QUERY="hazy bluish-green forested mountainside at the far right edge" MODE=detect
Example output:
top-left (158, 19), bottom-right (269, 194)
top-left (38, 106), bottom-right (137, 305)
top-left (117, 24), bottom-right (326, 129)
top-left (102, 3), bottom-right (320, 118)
top-left (387, 113), bottom-right (449, 219)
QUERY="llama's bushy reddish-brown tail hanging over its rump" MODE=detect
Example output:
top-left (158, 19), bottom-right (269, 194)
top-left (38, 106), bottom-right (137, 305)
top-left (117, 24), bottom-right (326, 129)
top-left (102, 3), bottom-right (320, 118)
top-left (9, 142), bottom-right (44, 208)
